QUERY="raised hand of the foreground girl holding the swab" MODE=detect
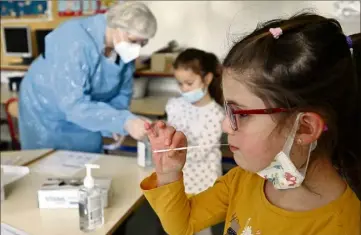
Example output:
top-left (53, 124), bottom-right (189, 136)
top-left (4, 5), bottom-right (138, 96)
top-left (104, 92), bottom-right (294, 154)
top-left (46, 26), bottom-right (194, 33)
top-left (144, 121), bottom-right (187, 186)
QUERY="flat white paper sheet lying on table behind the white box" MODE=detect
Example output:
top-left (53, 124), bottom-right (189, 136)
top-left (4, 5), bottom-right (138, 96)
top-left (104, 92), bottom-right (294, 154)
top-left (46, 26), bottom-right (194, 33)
top-left (31, 151), bottom-right (101, 176)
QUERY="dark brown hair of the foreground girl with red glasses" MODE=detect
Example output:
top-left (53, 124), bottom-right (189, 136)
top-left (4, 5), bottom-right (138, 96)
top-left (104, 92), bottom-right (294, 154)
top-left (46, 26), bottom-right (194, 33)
top-left (223, 13), bottom-right (361, 198)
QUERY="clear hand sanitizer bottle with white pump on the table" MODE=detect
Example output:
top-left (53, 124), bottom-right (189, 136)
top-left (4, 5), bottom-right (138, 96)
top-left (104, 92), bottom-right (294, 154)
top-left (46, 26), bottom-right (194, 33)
top-left (79, 164), bottom-right (104, 232)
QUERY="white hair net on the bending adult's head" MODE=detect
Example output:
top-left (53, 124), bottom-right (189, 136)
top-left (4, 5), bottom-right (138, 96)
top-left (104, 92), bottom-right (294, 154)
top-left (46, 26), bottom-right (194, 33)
top-left (107, 1), bottom-right (157, 39)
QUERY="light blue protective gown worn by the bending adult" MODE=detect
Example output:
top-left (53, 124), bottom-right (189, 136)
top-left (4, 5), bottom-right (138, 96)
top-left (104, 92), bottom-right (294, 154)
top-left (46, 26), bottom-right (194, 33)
top-left (19, 15), bottom-right (135, 152)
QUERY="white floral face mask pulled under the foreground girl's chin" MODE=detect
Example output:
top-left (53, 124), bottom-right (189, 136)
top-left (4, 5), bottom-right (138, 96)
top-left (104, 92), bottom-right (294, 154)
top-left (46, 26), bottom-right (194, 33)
top-left (257, 113), bottom-right (317, 189)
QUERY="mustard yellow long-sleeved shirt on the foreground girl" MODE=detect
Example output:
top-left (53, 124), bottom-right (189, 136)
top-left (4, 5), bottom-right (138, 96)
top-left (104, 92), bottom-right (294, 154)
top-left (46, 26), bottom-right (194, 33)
top-left (141, 167), bottom-right (361, 235)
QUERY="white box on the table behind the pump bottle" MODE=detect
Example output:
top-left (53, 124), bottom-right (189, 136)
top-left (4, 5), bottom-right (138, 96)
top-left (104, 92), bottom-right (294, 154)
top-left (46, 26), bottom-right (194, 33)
top-left (38, 177), bottom-right (112, 209)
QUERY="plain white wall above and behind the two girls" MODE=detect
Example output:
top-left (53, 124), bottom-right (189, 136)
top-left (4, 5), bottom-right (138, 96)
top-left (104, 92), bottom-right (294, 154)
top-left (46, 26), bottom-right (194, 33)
top-left (142, 1), bottom-right (360, 58)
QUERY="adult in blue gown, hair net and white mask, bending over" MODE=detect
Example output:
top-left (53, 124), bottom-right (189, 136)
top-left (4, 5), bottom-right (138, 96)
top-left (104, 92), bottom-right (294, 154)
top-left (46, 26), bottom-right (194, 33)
top-left (19, 2), bottom-right (157, 153)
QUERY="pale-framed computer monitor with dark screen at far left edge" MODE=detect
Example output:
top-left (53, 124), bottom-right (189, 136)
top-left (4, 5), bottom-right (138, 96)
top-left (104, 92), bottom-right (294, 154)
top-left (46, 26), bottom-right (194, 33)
top-left (2, 26), bottom-right (33, 60)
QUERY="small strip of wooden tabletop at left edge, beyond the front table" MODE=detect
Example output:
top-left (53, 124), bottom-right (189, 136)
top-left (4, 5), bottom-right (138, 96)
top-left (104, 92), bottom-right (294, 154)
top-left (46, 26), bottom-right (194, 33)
top-left (0, 149), bottom-right (53, 166)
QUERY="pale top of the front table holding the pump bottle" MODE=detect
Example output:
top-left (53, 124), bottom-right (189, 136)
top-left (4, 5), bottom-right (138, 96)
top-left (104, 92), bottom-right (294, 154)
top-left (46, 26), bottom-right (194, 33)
top-left (1, 151), bottom-right (153, 235)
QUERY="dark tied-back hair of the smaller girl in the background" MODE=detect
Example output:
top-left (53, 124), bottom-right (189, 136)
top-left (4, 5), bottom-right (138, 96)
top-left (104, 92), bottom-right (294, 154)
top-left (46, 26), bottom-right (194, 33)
top-left (173, 48), bottom-right (223, 106)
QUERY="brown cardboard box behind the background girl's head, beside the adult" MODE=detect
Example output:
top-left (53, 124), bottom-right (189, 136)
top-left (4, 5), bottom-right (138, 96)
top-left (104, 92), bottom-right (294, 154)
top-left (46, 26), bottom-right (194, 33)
top-left (150, 53), bottom-right (179, 73)
